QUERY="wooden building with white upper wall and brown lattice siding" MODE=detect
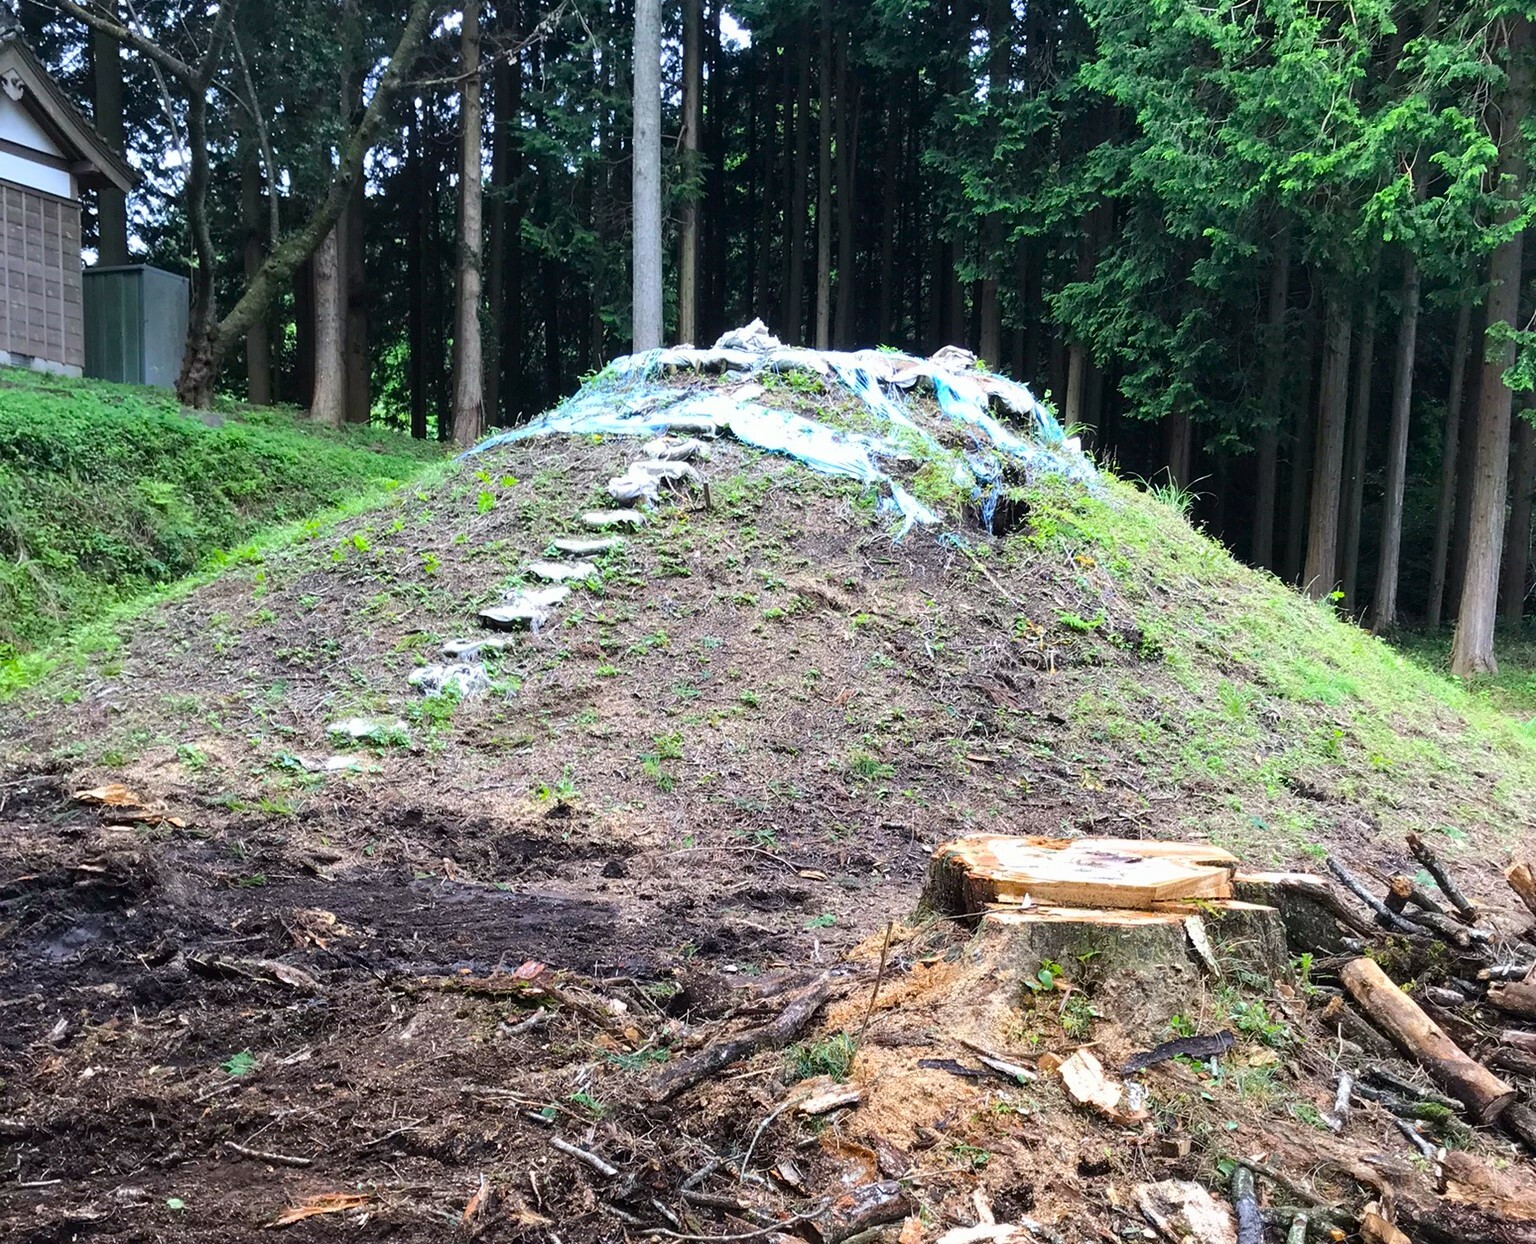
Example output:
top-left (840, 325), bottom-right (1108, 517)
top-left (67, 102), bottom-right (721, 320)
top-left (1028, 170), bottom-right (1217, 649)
top-left (0, 15), bottom-right (137, 376)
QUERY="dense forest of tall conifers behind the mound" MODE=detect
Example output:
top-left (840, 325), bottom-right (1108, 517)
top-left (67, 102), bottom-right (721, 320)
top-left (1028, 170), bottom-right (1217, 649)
top-left (20, 0), bottom-right (1536, 674)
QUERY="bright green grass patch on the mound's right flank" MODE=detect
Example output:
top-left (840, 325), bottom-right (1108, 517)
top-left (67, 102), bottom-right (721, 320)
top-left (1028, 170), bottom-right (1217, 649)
top-left (1006, 479), bottom-right (1536, 857)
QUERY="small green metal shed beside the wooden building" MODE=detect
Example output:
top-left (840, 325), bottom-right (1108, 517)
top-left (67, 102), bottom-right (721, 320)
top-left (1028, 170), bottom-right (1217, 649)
top-left (84, 264), bottom-right (190, 389)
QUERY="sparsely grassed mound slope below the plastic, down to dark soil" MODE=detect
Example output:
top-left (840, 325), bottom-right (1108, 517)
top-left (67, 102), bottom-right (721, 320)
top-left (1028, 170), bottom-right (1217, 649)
top-left (0, 368), bottom-right (1536, 877)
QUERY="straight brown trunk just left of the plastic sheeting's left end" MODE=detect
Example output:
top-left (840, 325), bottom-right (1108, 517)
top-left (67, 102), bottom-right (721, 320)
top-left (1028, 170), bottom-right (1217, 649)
top-left (453, 0), bottom-right (485, 445)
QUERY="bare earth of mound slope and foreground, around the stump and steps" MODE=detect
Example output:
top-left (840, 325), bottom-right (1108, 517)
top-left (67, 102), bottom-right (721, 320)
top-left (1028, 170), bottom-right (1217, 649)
top-left (0, 380), bottom-right (1536, 1244)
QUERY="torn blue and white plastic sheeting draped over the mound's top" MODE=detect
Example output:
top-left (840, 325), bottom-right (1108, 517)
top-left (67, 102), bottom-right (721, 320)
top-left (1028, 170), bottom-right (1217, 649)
top-left (470, 321), bottom-right (1098, 534)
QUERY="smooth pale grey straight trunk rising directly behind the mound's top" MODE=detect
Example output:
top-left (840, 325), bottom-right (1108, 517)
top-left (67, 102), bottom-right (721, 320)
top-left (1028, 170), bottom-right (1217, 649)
top-left (631, 0), bottom-right (662, 352)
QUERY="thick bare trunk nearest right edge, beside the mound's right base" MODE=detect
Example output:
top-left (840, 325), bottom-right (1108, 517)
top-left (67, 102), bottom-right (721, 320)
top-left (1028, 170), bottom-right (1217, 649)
top-left (1450, 17), bottom-right (1531, 679)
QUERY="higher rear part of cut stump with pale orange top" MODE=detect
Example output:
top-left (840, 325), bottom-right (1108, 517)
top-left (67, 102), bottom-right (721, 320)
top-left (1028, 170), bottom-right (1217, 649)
top-left (926, 834), bottom-right (1238, 917)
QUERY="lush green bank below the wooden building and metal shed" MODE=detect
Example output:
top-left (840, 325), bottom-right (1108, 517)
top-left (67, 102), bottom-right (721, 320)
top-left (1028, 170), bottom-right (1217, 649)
top-left (0, 367), bottom-right (438, 660)
